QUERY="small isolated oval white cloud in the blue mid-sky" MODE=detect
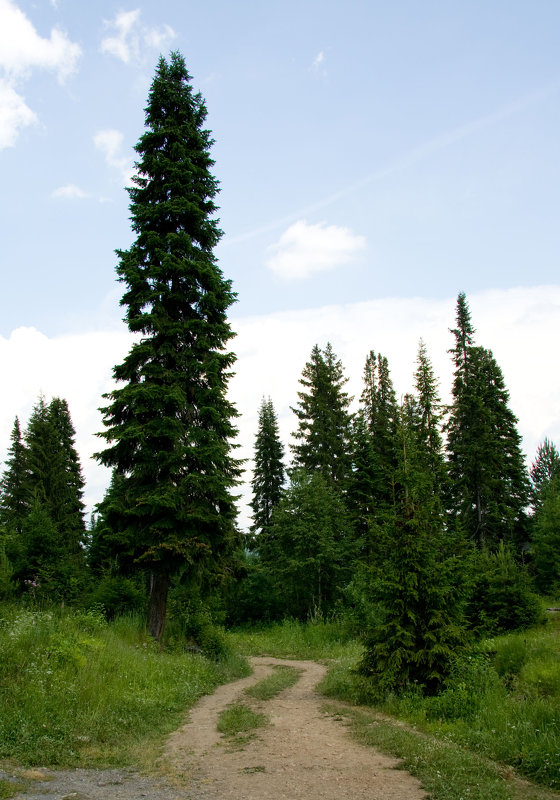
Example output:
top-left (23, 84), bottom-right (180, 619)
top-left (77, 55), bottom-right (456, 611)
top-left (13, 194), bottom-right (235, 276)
top-left (266, 220), bottom-right (366, 280)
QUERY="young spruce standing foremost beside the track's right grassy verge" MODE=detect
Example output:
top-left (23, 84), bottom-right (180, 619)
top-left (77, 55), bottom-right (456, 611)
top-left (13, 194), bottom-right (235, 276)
top-left (361, 406), bottom-right (465, 695)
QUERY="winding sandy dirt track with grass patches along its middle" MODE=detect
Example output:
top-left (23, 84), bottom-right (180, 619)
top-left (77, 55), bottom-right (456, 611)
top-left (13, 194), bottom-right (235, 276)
top-left (163, 658), bottom-right (426, 800)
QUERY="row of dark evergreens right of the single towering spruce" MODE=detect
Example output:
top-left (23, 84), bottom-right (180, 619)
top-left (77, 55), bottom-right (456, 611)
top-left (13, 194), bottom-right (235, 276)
top-left (242, 294), bottom-right (560, 690)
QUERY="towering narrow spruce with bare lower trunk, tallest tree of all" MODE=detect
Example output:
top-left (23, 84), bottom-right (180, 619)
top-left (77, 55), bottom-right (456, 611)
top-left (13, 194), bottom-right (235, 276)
top-left (98, 52), bottom-right (239, 639)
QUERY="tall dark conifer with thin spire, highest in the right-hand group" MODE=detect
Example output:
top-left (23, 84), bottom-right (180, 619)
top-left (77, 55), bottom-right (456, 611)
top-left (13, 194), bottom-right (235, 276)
top-left (446, 294), bottom-right (529, 548)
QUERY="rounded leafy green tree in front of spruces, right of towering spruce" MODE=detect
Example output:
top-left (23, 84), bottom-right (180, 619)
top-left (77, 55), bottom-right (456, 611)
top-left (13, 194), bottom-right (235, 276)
top-left (256, 470), bottom-right (354, 620)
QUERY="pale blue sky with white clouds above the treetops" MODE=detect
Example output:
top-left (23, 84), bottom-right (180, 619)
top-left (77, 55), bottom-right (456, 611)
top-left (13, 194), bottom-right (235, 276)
top-left (0, 0), bottom-right (560, 527)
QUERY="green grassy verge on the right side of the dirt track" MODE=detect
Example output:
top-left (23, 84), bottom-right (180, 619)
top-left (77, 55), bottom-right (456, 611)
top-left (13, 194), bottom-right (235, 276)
top-left (229, 614), bottom-right (560, 800)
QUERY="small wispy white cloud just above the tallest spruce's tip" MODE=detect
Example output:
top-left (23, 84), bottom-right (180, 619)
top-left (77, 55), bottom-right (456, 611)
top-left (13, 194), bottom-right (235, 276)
top-left (101, 8), bottom-right (176, 64)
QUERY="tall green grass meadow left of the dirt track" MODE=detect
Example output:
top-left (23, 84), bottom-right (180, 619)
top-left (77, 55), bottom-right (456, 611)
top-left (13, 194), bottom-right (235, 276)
top-left (0, 606), bottom-right (248, 765)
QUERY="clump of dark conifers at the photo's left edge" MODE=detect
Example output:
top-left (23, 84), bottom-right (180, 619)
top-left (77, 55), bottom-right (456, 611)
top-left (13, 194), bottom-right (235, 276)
top-left (1, 397), bottom-right (87, 600)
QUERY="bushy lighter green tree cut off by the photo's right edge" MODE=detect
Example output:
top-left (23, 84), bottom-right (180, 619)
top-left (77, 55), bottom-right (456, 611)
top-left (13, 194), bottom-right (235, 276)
top-left (531, 473), bottom-right (560, 594)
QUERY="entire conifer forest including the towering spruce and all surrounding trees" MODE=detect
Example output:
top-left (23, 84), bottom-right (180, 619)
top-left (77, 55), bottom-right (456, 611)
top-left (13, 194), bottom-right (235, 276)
top-left (0, 52), bottom-right (560, 696)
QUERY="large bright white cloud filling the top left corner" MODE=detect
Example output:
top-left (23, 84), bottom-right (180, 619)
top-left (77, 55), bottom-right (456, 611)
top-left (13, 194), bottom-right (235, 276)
top-left (0, 0), bottom-right (82, 150)
